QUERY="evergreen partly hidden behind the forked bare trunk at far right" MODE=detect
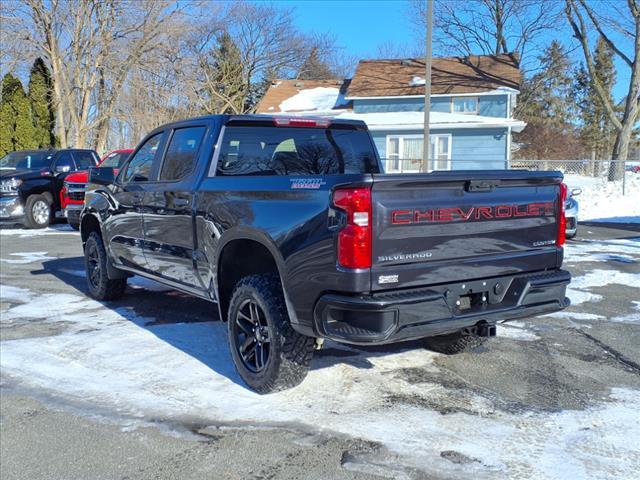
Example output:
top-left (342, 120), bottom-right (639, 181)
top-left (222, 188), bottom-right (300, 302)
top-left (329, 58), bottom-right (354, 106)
top-left (574, 37), bottom-right (616, 159)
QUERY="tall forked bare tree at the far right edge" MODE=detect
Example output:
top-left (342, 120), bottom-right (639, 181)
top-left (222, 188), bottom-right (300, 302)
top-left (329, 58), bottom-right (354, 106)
top-left (565, 0), bottom-right (640, 180)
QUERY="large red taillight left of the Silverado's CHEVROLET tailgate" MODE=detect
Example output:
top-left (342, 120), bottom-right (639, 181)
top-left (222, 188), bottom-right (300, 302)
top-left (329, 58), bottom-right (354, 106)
top-left (333, 188), bottom-right (372, 268)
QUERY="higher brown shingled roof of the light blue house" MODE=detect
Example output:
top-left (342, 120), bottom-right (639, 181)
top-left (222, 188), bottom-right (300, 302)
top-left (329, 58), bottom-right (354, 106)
top-left (347, 54), bottom-right (522, 98)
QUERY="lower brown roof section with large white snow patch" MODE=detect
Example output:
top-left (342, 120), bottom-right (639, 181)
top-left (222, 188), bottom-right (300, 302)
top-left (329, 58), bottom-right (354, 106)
top-left (256, 79), bottom-right (349, 113)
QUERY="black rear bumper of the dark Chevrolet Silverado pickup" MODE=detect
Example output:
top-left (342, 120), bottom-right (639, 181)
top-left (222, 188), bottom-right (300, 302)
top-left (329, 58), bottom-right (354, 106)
top-left (314, 270), bottom-right (571, 344)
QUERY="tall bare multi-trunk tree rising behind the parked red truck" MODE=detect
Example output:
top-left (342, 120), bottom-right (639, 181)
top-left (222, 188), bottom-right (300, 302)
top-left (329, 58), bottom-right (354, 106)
top-left (20, 0), bottom-right (189, 151)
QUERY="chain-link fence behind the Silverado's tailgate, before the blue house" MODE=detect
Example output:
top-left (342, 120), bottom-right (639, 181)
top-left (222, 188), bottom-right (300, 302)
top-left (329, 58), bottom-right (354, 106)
top-left (382, 158), bottom-right (640, 195)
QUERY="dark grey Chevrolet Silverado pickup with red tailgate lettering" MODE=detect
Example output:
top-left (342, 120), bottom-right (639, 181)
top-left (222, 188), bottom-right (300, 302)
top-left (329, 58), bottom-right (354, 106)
top-left (80, 115), bottom-right (570, 393)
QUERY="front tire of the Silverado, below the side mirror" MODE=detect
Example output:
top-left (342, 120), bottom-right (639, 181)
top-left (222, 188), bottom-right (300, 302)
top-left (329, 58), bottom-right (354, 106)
top-left (84, 232), bottom-right (127, 301)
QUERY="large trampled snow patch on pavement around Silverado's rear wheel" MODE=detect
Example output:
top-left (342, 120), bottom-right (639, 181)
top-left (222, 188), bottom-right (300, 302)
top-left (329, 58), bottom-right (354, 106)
top-left (0, 280), bottom-right (640, 480)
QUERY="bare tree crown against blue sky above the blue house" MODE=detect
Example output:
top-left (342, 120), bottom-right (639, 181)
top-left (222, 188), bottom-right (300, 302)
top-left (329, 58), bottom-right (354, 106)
top-left (412, 0), bottom-right (560, 71)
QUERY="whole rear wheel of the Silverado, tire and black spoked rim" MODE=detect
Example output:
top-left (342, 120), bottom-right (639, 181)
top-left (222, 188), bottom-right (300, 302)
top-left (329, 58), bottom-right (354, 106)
top-left (227, 274), bottom-right (315, 393)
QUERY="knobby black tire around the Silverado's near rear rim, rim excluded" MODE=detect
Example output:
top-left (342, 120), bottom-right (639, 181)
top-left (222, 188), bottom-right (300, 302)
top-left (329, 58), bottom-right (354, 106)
top-left (227, 274), bottom-right (315, 394)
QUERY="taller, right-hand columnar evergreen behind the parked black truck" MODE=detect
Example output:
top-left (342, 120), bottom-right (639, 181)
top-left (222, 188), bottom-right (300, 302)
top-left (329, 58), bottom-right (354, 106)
top-left (29, 58), bottom-right (55, 148)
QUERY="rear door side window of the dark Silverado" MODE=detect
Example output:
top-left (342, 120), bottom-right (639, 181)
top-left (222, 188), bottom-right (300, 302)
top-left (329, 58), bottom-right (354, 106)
top-left (160, 127), bottom-right (206, 181)
